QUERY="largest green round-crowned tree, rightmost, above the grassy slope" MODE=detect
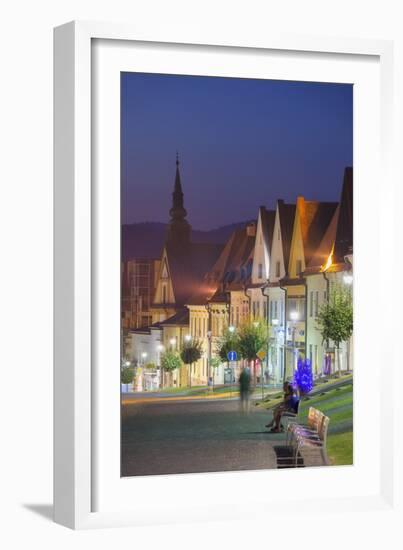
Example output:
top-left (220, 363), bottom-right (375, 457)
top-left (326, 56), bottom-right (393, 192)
top-left (317, 284), bottom-right (353, 376)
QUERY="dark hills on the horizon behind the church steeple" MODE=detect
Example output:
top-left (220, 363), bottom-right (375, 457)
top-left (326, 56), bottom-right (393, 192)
top-left (122, 221), bottom-right (252, 261)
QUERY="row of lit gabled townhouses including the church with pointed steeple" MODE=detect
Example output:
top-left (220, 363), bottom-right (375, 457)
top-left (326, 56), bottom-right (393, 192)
top-left (130, 162), bottom-right (353, 389)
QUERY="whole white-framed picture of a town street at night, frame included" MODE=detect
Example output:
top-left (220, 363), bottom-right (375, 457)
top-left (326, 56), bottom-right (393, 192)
top-left (54, 23), bottom-right (393, 528)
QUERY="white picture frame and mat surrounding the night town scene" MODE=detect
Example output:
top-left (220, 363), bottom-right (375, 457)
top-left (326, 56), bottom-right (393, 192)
top-left (54, 22), bottom-right (394, 529)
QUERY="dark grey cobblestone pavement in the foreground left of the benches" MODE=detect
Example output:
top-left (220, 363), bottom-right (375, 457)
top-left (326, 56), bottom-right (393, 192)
top-left (122, 399), bottom-right (284, 476)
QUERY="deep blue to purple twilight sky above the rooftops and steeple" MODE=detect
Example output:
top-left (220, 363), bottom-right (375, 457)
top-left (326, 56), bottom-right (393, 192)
top-left (121, 73), bottom-right (353, 229)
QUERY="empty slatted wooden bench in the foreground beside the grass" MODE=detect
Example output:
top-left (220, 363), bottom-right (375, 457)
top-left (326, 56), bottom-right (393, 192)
top-left (287, 407), bottom-right (330, 466)
